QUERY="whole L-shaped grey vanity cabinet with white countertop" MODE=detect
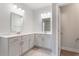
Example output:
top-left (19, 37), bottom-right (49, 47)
top-left (0, 34), bottom-right (52, 56)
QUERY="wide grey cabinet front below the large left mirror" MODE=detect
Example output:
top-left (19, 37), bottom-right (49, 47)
top-left (9, 37), bottom-right (21, 56)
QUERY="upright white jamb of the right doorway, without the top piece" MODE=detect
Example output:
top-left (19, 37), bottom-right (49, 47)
top-left (56, 6), bottom-right (61, 56)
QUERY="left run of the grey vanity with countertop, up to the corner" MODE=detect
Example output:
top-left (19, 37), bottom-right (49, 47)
top-left (0, 34), bottom-right (34, 56)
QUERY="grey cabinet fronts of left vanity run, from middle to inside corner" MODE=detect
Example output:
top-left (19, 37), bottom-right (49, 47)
top-left (22, 34), bottom-right (34, 53)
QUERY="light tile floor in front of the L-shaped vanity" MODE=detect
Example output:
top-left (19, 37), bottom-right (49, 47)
top-left (24, 48), bottom-right (52, 56)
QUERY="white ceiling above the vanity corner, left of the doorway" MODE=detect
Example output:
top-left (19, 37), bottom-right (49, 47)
top-left (25, 3), bottom-right (51, 10)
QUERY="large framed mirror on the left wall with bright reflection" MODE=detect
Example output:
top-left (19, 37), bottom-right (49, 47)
top-left (10, 13), bottom-right (23, 33)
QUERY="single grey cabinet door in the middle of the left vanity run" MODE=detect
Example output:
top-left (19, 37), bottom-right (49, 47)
top-left (22, 35), bottom-right (29, 54)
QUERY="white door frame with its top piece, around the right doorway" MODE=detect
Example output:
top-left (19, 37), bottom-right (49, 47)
top-left (56, 3), bottom-right (68, 56)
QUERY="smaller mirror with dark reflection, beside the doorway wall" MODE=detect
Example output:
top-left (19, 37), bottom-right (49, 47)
top-left (42, 18), bottom-right (51, 32)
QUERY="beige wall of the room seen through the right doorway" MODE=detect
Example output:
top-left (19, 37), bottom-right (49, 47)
top-left (61, 4), bottom-right (79, 50)
